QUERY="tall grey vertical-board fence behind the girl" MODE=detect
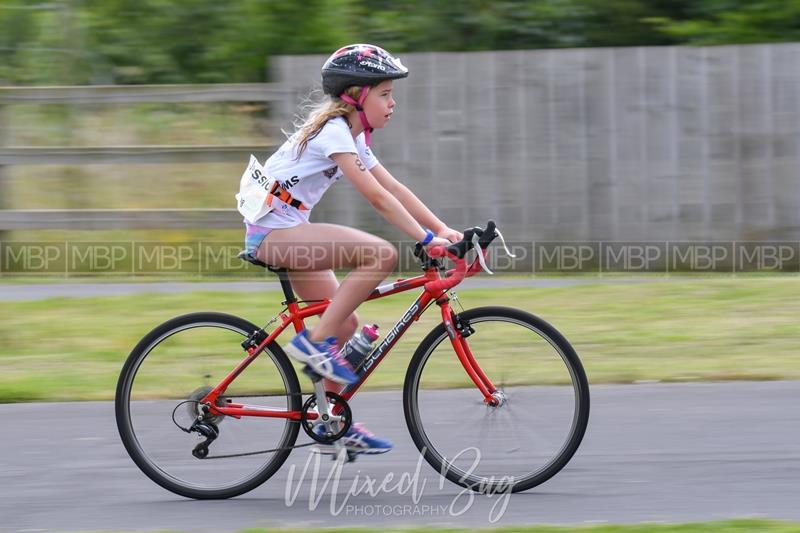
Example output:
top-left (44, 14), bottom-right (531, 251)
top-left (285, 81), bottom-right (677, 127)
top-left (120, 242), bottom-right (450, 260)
top-left (274, 44), bottom-right (800, 241)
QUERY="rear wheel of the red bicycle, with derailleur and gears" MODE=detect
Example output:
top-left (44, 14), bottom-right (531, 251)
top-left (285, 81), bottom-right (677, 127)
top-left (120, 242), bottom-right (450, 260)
top-left (115, 313), bottom-right (301, 499)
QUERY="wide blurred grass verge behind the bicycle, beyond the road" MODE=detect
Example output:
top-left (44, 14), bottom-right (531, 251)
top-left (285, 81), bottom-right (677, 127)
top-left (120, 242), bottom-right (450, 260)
top-left (0, 277), bottom-right (800, 402)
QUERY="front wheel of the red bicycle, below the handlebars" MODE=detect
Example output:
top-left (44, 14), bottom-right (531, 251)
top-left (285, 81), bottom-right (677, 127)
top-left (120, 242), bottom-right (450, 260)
top-left (403, 307), bottom-right (589, 493)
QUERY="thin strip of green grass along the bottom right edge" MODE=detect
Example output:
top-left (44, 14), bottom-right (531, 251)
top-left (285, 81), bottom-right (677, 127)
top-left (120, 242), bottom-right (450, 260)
top-left (233, 520), bottom-right (800, 533)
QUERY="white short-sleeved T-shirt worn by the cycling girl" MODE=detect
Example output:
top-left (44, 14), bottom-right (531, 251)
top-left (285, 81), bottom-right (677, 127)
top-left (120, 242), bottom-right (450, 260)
top-left (255, 117), bottom-right (378, 229)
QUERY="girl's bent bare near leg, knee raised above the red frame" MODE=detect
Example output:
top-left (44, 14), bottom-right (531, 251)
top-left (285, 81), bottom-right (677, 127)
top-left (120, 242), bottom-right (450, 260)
top-left (258, 224), bottom-right (397, 342)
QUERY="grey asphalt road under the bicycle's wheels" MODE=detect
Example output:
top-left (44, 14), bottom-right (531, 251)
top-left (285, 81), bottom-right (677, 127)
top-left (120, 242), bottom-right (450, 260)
top-left (0, 382), bottom-right (800, 532)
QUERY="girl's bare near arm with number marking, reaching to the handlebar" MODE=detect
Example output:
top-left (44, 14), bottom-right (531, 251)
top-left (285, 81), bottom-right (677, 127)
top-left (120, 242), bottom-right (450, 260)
top-left (331, 153), bottom-right (449, 245)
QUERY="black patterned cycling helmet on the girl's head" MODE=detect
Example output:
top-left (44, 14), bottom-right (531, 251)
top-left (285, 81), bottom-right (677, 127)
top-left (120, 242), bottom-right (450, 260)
top-left (322, 44), bottom-right (408, 96)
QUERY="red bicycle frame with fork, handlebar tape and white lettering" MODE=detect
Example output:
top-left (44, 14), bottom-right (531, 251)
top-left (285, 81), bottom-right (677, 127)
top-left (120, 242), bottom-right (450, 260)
top-left (201, 250), bottom-right (497, 421)
